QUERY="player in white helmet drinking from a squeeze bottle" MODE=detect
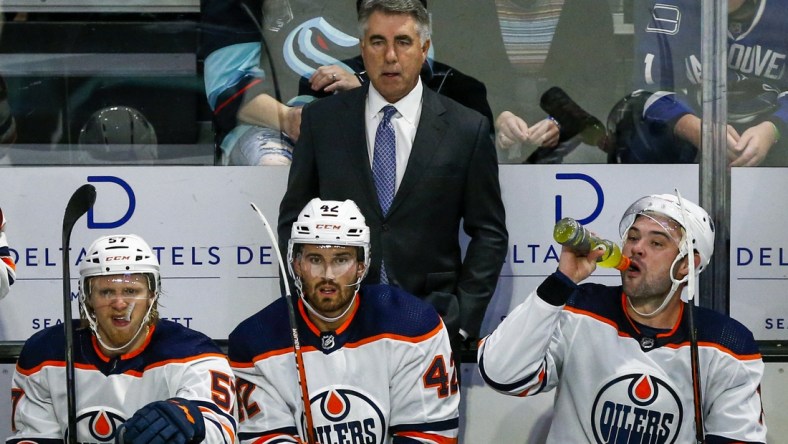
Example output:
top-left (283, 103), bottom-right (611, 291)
top-left (478, 195), bottom-right (766, 443)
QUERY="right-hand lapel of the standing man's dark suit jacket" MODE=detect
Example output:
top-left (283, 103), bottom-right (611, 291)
top-left (390, 87), bottom-right (448, 214)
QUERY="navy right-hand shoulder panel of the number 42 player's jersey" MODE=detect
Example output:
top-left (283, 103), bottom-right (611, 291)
top-left (354, 285), bottom-right (441, 337)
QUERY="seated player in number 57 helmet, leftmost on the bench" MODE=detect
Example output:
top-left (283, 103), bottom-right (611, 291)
top-left (7, 234), bottom-right (237, 444)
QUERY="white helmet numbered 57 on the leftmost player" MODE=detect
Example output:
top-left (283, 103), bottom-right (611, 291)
top-left (79, 234), bottom-right (161, 301)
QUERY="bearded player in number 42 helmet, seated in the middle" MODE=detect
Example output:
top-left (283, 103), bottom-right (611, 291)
top-left (229, 199), bottom-right (460, 444)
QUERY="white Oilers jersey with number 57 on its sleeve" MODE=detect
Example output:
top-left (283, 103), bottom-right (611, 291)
top-left (6, 320), bottom-right (237, 444)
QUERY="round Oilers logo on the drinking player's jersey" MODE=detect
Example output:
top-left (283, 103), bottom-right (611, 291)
top-left (591, 373), bottom-right (684, 444)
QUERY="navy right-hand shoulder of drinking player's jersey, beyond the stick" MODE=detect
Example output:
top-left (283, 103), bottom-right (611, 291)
top-left (695, 307), bottom-right (760, 356)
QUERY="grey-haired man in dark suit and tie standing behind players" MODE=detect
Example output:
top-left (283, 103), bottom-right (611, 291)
top-left (279, 0), bottom-right (508, 359)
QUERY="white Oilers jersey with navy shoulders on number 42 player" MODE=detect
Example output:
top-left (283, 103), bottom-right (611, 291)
top-left (228, 285), bottom-right (460, 444)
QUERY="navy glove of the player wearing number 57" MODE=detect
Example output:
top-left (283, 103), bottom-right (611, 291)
top-left (115, 398), bottom-right (205, 444)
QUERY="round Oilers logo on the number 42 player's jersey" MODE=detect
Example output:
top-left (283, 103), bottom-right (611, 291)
top-left (312, 387), bottom-right (386, 444)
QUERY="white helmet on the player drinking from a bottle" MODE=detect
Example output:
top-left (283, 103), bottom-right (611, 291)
top-left (618, 194), bottom-right (714, 274)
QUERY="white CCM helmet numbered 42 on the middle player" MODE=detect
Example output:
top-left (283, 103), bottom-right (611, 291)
top-left (287, 198), bottom-right (370, 282)
